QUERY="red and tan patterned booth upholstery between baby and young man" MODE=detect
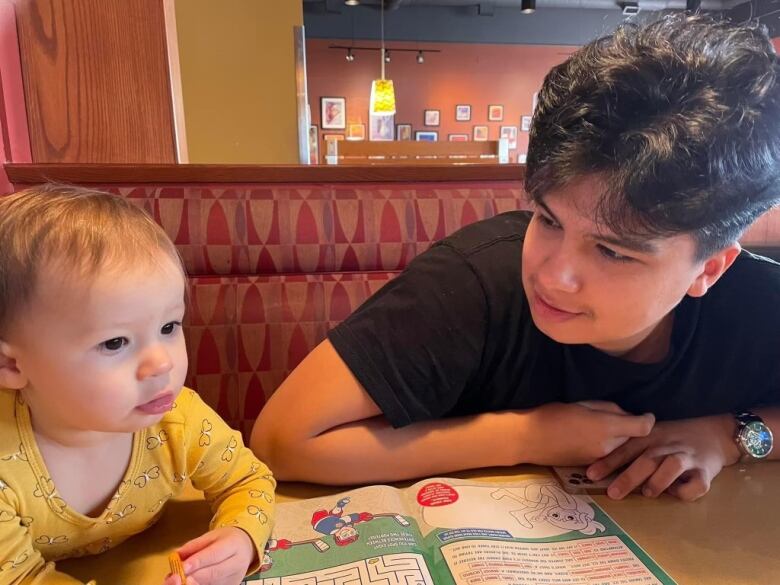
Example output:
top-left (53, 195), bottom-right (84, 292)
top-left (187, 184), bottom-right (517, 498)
top-left (95, 181), bottom-right (524, 437)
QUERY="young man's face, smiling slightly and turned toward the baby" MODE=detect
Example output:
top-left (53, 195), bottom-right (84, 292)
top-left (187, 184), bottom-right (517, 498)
top-left (522, 178), bottom-right (738, 355)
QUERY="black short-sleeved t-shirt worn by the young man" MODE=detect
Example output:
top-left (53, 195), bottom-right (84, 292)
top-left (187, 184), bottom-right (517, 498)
top-left (329, 211), bottom-right (780, 427)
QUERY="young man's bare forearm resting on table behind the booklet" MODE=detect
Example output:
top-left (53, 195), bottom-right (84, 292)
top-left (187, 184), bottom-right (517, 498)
top-left (271, 411), bottom-right (528, 484)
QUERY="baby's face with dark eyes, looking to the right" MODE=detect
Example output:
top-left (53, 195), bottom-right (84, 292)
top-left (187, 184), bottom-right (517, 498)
top-left (6, 253), bottom-right (187, 432)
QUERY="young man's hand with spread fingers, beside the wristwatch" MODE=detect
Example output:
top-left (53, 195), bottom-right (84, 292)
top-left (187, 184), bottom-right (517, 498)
top-left (587, 415), bottom-right (739, 502)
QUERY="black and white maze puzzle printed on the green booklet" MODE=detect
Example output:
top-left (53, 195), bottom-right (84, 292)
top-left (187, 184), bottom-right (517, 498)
top-left (247, 553), bottom-right (434, 585)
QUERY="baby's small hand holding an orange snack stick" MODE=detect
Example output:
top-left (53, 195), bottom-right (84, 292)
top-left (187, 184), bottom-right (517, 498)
top-left (164, 526), bottom-right (255, 585)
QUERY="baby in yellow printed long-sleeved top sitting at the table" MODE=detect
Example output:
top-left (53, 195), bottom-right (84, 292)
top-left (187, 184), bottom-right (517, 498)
top-left (0, 185), bottom-right (276, 585)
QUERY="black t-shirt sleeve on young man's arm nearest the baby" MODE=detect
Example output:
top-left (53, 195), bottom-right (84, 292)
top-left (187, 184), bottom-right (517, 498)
top-left (328, 244), bottom-right (487, 427)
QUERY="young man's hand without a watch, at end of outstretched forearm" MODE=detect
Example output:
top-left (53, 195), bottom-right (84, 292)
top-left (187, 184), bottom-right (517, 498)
top-left (518, 401), bottom-right (655, 466)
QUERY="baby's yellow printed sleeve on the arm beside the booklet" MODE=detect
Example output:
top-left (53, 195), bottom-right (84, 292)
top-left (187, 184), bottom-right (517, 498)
top-left (183, 389), bottom-right (276, 573)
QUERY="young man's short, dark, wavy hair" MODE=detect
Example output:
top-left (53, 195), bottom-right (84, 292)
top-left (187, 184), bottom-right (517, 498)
top-left (526, 14), bottom-right (780, 259)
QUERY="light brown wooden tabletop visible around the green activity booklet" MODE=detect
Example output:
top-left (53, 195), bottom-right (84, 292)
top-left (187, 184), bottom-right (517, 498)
top-left (58, 462), bottom-right (780, 585)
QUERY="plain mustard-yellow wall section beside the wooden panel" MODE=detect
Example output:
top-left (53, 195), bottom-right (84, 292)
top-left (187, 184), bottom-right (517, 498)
top-left (175, 0), bottom-right (303, 164)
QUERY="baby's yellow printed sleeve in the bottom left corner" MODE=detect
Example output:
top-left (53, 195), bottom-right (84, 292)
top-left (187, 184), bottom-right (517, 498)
top-left (0, 488), bottom-right (95, 585)
